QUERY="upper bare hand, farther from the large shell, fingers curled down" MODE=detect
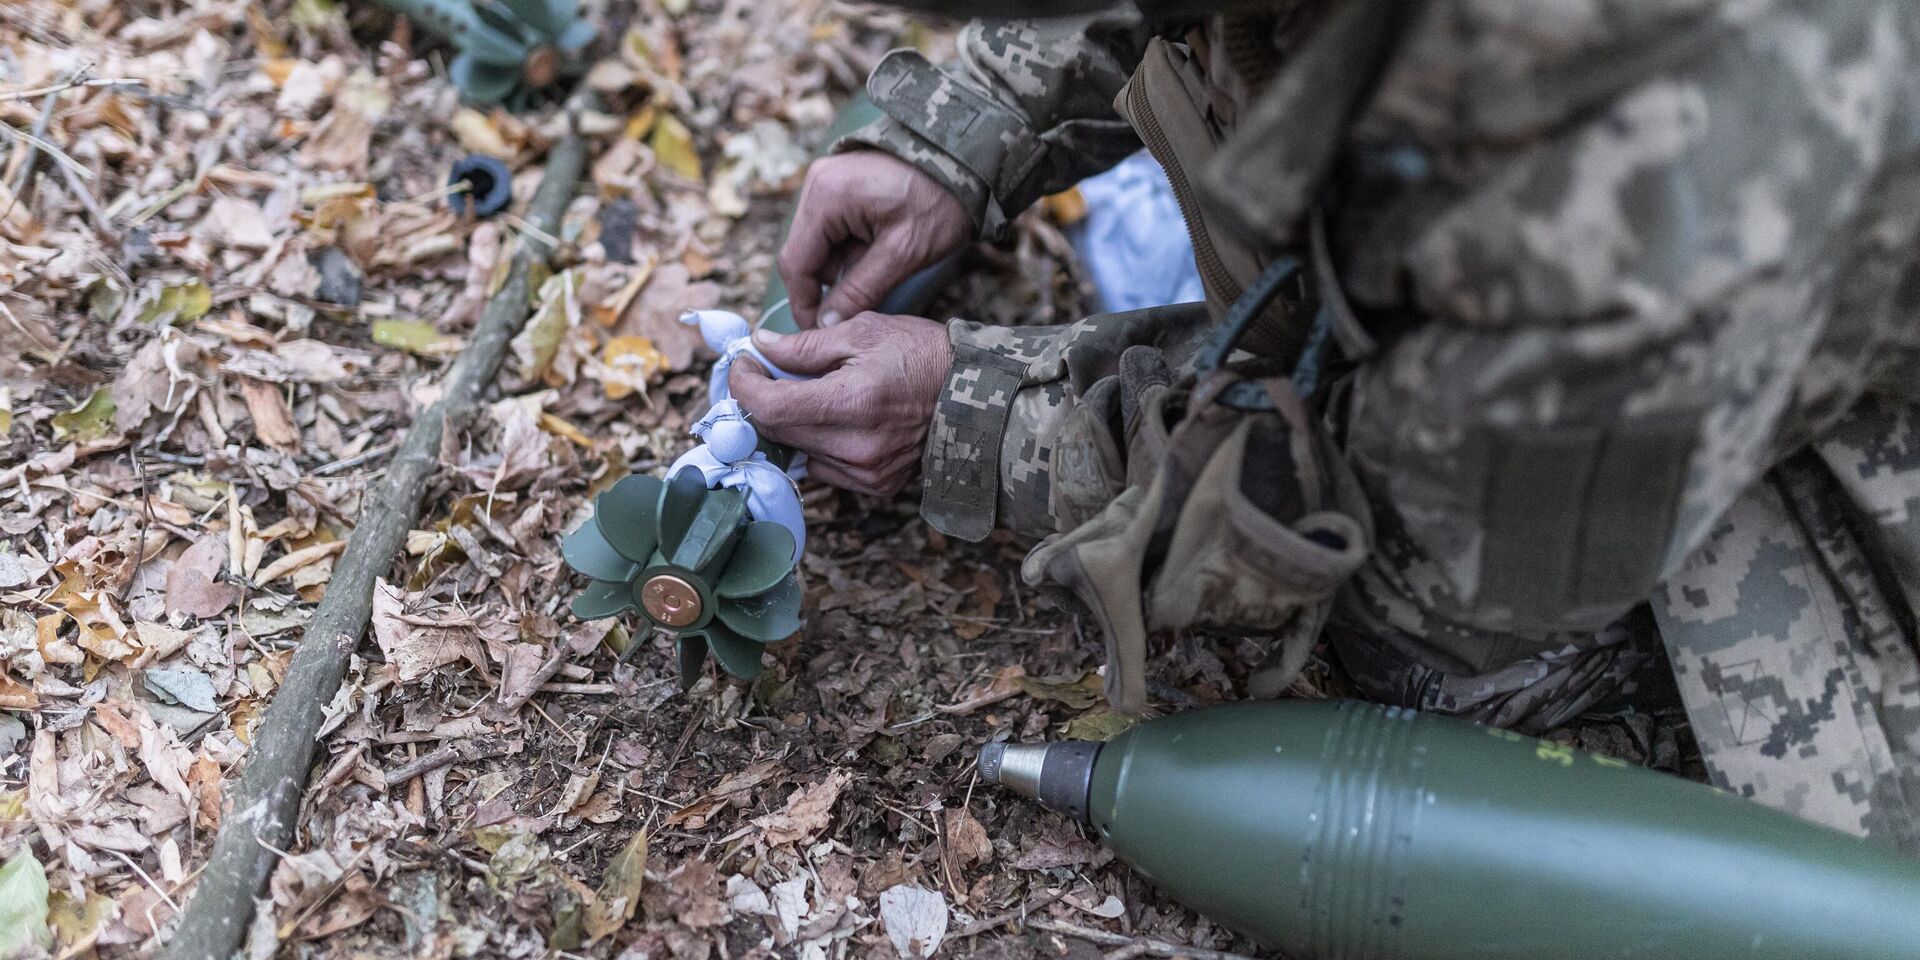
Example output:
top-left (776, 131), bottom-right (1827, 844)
top-left (780, 150), bottom-right (973, 326)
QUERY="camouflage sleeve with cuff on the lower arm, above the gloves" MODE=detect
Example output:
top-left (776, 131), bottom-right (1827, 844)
top-left (920, 303), bottom-right (1208, 540)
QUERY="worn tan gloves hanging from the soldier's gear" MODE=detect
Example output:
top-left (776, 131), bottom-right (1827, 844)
top-left (1021, 372), bottom-right (1369, 712)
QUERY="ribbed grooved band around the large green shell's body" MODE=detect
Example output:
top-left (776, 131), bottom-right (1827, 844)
top-left (1300, 703), bottom-right (1425, 960)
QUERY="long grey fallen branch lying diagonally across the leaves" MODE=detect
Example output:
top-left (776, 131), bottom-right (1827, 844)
top-left (163, 107), bottom-right (588, 960)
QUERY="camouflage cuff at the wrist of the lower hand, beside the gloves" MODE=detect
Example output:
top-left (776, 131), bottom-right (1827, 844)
top-left (920, 330), bottom-right (1027, 540)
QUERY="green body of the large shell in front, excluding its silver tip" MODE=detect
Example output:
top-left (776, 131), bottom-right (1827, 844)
top-left (1075, 701), bottom-right (1920, 960)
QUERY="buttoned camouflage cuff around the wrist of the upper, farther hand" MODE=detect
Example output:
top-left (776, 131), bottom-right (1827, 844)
top-left (866, 50), bottom-right (1041, 234)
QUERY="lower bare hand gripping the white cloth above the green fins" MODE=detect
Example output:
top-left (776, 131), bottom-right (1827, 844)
top-left (728, 313), bottom-right (952, 495)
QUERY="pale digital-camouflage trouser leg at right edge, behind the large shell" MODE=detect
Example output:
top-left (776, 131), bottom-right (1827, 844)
top-left (1655, 403), bottom-right (1920, 852)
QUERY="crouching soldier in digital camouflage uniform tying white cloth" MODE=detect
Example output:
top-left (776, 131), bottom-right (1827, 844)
top-left (735, 0), bottom-right (1920, 852)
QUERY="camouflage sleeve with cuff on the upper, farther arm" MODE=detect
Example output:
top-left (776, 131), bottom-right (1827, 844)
top-left (833, 8), bottom-right (1150, 238)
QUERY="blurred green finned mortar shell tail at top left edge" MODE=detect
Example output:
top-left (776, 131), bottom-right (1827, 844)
top-left (378, 0), bottom-right (597, 109)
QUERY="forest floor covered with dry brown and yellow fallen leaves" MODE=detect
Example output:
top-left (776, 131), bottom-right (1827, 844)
top-left (0, 0), bottom-right (1697, 958)
